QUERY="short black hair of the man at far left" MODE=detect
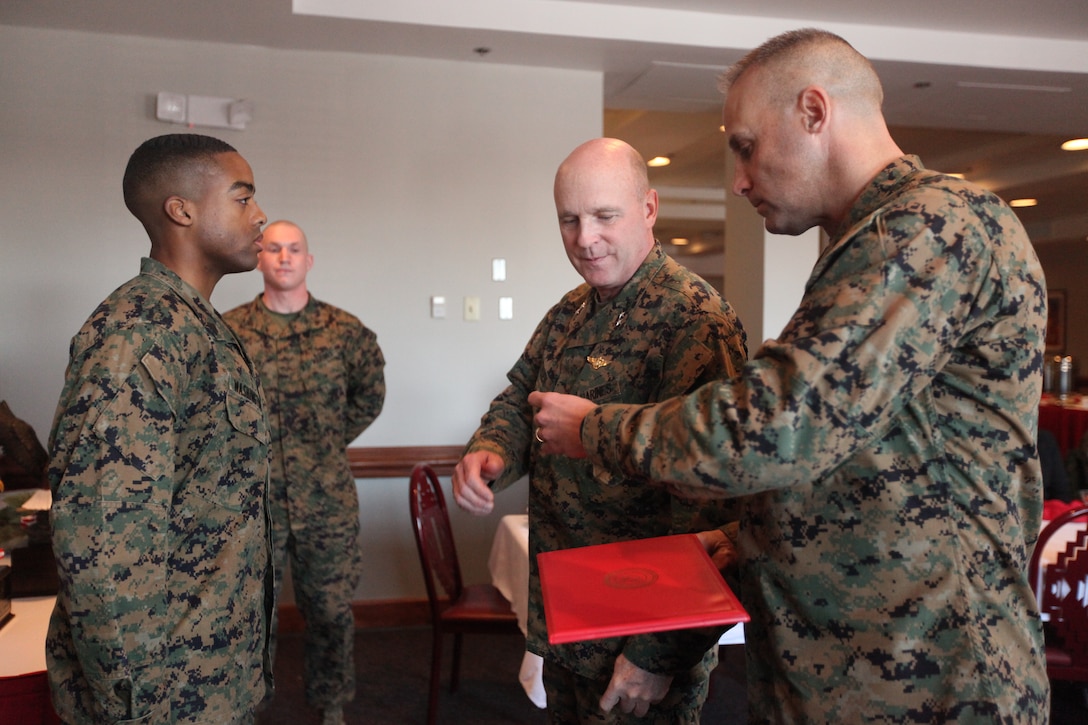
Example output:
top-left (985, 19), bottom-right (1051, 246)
top-left (121, 134), bottom-right (237, 217)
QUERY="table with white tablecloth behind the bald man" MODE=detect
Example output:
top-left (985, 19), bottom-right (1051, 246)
top-left (487, 514), bottom-right (744, 708)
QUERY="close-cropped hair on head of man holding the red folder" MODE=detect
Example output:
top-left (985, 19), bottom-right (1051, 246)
top-left (718, 28), bottom-right (883, 115)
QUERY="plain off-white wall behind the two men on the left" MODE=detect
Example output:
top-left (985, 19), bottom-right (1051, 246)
top-left (0, 26), bottom-right (603, 599)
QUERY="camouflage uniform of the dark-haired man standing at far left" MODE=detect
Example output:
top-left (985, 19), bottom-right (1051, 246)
top-left (46, 259), bottom-right (272, 725)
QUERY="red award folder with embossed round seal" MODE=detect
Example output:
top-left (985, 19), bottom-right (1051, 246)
top-left (536, 533), bottom-right (749, 644)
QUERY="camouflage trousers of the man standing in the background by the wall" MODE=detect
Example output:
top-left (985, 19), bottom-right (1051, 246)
top-left (272, 500), bottom-right (362, 709)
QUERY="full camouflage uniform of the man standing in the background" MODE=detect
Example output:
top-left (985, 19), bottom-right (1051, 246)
top-left (224, 295), bottom-right (385, 708)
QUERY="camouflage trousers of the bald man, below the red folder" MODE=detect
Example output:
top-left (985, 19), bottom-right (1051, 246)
top-left (544, 660), bottom-right (710, 725)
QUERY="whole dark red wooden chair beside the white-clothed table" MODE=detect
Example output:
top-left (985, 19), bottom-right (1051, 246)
top-left (409, 464), bottom-right (523, 725)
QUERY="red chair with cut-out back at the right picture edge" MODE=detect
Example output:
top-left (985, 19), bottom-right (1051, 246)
top-left (1028, 503), bottom-right (1088, 683)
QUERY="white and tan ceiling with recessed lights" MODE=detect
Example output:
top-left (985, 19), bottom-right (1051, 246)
top-left (0, 0), bottom-right (1088, 251)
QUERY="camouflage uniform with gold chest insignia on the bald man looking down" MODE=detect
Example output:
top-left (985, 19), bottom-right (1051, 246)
top-left (468, 245), bottom-right (746, 722)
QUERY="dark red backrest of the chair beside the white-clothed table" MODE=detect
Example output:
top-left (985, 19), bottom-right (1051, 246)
top-left (409, 464), bottom-right (462, 617)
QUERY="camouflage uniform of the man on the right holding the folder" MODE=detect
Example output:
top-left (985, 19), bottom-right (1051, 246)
top-left (582, 156), bottom-right (1049, 723)
